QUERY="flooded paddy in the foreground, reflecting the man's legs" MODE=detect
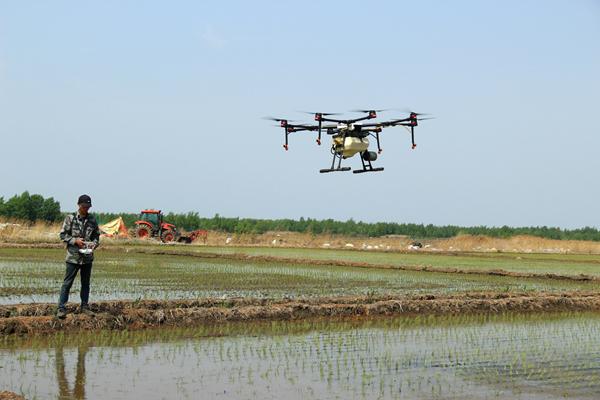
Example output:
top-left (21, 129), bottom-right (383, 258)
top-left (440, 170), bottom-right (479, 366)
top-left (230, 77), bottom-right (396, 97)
top-left (0, 313), bottom-right (600, 399)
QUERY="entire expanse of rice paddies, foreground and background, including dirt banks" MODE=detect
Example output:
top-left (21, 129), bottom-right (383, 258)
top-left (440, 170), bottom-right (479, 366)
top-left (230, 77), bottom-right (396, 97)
top-left (0, 246), bottom-right (600, 399)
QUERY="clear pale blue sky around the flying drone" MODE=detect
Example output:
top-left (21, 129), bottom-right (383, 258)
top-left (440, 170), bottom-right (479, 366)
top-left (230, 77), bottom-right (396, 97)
top-left (0, 0), bottom-right (600, 228)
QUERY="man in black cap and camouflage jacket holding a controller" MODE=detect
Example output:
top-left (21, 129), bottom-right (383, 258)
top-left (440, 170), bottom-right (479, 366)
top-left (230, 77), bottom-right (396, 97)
top-left (56, 194), bottom-right (100, 318)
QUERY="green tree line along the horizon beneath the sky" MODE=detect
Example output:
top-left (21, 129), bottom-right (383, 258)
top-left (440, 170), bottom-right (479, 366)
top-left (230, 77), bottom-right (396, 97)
top-left (0, 192), bottom-right (600, 241)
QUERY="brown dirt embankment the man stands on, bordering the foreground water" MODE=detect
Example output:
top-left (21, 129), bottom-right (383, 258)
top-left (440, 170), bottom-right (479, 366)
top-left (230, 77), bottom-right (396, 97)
top-left (0, 292), bottom-right (600, 335)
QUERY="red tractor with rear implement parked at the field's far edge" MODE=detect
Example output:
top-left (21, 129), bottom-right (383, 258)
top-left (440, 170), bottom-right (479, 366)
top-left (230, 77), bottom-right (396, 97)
top-left (134, 210), bottom-right (208, 243)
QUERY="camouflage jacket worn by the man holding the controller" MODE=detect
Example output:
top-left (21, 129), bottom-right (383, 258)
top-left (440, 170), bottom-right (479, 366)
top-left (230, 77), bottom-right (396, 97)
top-left (60, 213), bottom-right (100, 264)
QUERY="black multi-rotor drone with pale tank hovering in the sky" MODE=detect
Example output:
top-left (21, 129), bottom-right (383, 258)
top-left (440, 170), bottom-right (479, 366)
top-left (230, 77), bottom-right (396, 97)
top-left (266, 110), bottom-right (433, 174)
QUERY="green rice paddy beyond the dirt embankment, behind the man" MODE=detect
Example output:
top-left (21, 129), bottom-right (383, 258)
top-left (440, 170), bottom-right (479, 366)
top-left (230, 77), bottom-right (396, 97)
top-left (0, 249), bottom-right (600, 304)
